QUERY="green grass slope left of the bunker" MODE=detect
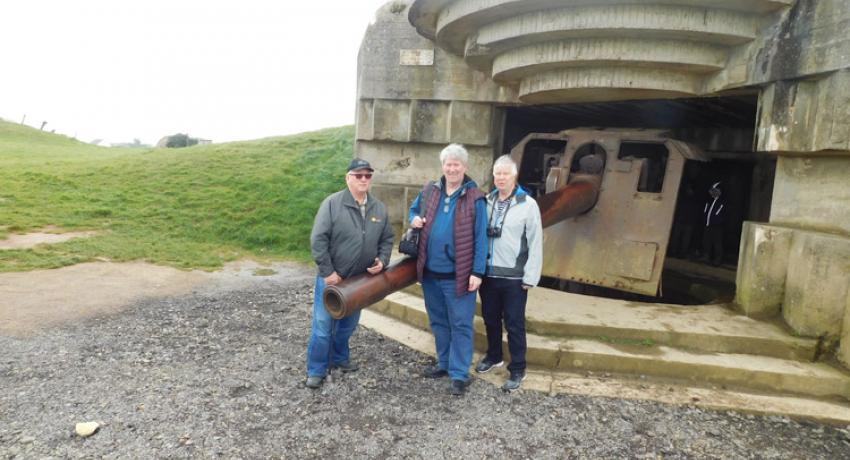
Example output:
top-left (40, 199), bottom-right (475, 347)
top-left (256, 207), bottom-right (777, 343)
top-left (0, 121), bottom-right (354, 272)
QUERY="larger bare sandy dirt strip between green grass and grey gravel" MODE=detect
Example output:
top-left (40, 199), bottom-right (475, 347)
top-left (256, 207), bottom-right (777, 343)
top-left (0, 261), bottom-right (310, 336)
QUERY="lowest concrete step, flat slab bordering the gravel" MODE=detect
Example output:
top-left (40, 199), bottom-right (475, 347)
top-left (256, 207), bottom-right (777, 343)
top-left (360, 309), bottom-right (850, 427)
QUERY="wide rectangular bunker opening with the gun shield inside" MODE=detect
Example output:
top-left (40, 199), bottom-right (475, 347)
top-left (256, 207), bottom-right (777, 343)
top-left (501, 94), bottom-right (776, 305)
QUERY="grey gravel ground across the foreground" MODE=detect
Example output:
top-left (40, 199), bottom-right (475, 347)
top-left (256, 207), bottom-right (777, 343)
top-left (0, 276), bottom-right (850, 459)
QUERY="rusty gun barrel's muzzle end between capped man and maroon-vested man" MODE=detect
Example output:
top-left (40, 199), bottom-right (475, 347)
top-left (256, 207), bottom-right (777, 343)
top-left (322, 257), bottom-right (416, 319)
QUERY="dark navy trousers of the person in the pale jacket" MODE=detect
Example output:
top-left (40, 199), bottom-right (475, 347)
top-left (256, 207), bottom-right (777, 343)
top-left (479, 277), bottom-right (528, 373)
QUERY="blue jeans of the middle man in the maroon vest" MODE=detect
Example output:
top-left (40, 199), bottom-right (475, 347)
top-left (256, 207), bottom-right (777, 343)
top-left (422, 275), bottom-right (475, 381)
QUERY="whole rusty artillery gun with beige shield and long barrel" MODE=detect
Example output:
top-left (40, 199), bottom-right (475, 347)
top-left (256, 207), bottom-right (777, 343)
top-left (324, 129), bottom-right (708, 318)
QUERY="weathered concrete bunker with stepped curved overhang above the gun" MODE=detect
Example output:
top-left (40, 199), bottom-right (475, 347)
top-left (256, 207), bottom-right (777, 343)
top-left (355, 0), bottom-right (850, 365)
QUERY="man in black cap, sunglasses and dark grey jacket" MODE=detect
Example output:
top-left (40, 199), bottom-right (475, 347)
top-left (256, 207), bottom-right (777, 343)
top-left (305, 158), bottom-right (393, 388)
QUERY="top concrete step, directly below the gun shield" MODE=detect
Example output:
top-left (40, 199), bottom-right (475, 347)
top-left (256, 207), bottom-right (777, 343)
top-left (398, 284), bottom-right (817, 361)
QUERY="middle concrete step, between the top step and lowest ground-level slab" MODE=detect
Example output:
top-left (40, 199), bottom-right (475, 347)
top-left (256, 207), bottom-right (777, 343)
top-left (371, 292), bottom-right (850, 399)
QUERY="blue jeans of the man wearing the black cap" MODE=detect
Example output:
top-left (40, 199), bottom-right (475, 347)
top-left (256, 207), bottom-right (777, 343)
top-left (307, 276), bottom-right (360, 377)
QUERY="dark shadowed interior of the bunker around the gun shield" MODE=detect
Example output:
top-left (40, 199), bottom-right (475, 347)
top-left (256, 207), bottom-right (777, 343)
top-left (501, 94), bottom-right (776, 305)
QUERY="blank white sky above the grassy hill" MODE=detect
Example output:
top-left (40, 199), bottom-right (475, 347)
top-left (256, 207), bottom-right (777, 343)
top-left (0, 0), bottom-right (387, 144)
